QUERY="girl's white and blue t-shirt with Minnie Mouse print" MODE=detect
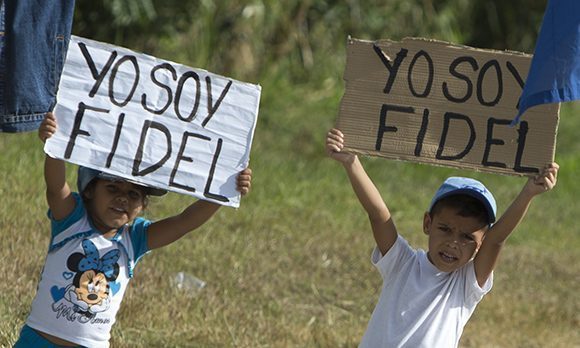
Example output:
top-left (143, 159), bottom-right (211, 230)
top-left (26, 193), bottom-right (151, 347)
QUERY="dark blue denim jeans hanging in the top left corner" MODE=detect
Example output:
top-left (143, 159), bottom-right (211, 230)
top-left (0, 0), bottom-right (75, 133)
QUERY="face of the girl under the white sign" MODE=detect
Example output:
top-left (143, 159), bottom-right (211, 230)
top-left (85, 179), bottom-right (145, 235)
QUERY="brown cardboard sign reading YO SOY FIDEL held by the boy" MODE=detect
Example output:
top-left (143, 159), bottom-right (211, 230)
top-left (336, 38), bottom-right (559, 175)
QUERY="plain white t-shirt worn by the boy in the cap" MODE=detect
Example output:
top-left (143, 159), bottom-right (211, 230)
top-left (359, 236), bottom-right (493, 348)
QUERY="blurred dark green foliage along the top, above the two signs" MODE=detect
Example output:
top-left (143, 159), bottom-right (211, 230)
top-left (74, 0), bottom-right (545, 82)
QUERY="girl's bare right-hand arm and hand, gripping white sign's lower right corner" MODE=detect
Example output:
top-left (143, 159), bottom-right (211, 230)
top-left (147, 168), bottom-right (252, 249)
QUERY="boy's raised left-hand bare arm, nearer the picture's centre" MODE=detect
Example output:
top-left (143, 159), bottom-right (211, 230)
top-left (326, 129), bottom-right (397, 255)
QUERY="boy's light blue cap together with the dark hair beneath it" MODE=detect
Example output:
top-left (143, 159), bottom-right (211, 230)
top-left (429, 177), bottom-right (497, 224)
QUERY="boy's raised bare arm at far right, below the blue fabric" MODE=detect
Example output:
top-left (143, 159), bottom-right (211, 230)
top-left (474, 163), bottom-right (559, 286)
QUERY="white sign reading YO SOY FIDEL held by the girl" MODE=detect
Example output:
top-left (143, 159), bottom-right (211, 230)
top-left (45, 36), bottom-right (261, 207)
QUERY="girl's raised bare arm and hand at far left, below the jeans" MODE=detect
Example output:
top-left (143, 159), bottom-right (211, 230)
top-left (38, 112), bottom-right (75, 220)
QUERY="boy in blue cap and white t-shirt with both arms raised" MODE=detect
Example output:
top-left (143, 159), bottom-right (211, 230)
top-left (326, 129), bottom-right (558, 348)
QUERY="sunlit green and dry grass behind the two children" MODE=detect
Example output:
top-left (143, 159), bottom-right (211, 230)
top-left (0, 21), bottom-right (580, 347)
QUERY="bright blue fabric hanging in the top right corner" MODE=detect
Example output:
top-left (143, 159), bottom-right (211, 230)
top-left (513, 0), bottom-right (580, 124)
